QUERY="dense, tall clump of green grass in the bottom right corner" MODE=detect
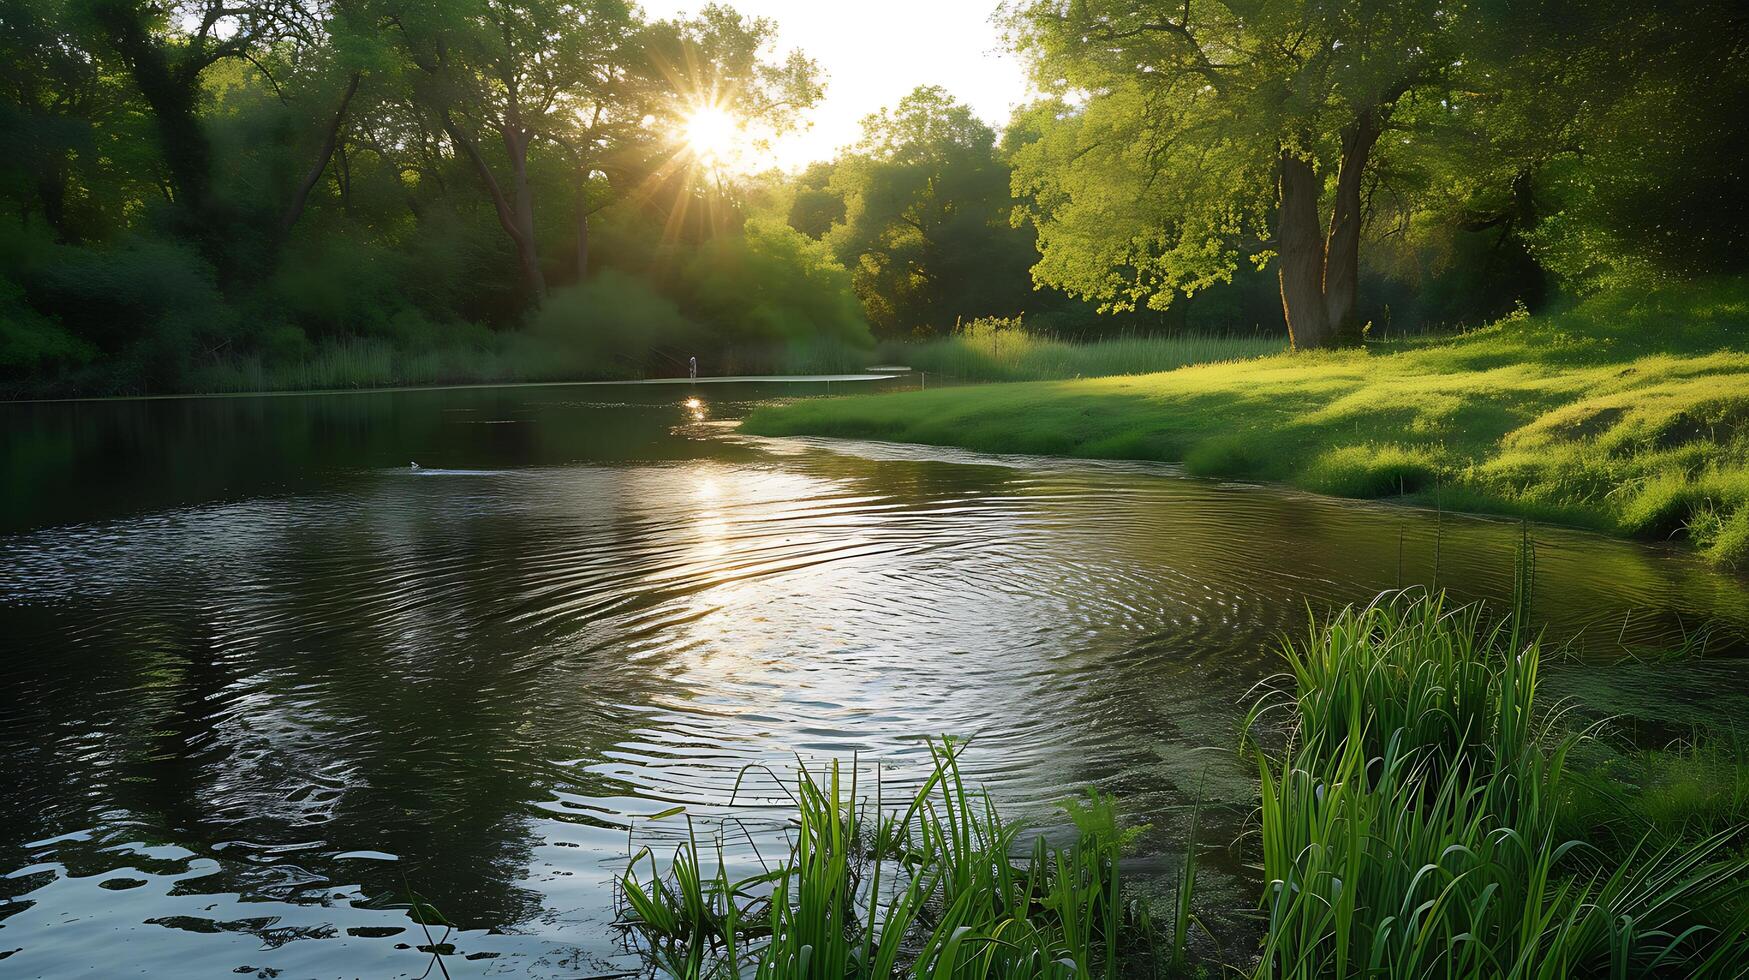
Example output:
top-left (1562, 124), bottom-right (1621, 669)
top-left (1252, 593), bottom-right (1749, 978)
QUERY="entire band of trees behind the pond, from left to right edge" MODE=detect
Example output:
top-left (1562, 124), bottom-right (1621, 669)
top-left (0, 0), bottom-right (1749, 390)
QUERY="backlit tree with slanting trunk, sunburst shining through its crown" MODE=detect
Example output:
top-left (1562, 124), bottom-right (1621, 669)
top-left (394, 0), bottom-right (819, 303)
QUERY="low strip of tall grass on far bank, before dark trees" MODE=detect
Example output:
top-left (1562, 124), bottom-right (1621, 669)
top-left (881, 317), bottom-right (1282, 382)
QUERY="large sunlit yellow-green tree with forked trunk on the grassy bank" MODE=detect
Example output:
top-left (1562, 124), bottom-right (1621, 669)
top-left (1011, 0), bottom-right (1462, 348)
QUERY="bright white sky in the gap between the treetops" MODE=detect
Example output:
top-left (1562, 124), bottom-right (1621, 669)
top-left (644, 0), bottom-right (1027, 170)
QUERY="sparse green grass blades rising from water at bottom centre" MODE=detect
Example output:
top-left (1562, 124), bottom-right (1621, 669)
top-left (621, 740), bottom-right (1195, 980)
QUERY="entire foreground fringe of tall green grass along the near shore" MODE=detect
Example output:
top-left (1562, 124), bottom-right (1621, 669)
top-left (623, 581), bottom-right (1749, 980)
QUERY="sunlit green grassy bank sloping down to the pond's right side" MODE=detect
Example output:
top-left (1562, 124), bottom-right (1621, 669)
top-left (747, 282), bottom-right (1749, 564)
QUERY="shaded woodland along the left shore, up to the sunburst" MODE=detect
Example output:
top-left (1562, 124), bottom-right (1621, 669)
top-left (0, 0), bottom-right (868, 390)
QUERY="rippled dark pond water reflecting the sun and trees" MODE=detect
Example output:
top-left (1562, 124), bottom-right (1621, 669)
top-left (0, 385), bottom-right (1749, 978)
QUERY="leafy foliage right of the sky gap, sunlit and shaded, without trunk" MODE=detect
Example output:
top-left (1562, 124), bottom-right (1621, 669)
top-left (1007, 0), bottom-right (1749, 341)
